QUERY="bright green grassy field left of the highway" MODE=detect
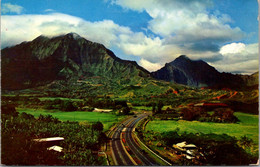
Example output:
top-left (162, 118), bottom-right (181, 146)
top-left (17, 108), bottom-right (124, 130)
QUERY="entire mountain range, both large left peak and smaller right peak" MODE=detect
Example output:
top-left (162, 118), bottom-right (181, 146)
top-left (1, 33), bottom-right (258, 95)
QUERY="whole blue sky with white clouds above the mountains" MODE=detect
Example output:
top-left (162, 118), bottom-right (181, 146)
top-left (1, 0), bottom-right (259, 74)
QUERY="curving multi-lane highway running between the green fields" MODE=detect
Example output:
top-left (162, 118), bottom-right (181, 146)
top-left (110, 114), bottom-right (160, 166)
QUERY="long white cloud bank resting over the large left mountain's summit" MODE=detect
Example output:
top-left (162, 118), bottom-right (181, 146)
top-left (1, 13), bottom-right (132, 47)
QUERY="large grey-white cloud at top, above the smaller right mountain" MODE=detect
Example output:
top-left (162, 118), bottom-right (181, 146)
top-left (112, 0), bottom-right (245, 50)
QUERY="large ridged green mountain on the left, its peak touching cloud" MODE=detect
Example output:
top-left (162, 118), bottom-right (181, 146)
top-left (1, 33), bottom-right (150, 90)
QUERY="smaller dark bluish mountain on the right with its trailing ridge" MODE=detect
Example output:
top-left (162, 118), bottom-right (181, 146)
top-left (152, 55), bottom-right (258, 88)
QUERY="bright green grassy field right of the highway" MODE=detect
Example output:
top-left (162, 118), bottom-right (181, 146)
top-left (146, 112), bottom-right (259, 144)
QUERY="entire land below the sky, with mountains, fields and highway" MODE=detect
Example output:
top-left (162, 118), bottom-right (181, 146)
top-left (1, 33), bottom-right (259, 165)
